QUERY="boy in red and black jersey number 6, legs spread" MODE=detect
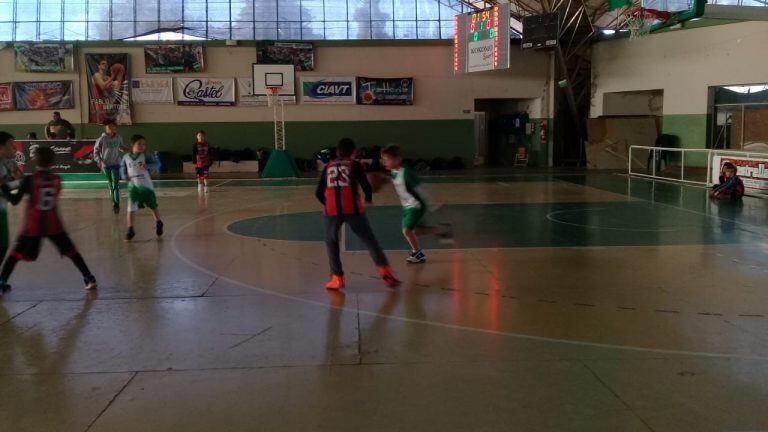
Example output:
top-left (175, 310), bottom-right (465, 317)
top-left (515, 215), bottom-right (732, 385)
top-left (0, 147), bottom-right (97, 291)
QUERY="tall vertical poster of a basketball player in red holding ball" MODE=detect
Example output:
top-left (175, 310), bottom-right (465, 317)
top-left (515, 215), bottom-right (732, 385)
top-left (85, 54), bottom-right (131, 124)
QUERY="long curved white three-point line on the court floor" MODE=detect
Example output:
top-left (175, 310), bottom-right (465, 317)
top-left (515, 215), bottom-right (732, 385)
top-left (171, 205), bottom-right (768, 360)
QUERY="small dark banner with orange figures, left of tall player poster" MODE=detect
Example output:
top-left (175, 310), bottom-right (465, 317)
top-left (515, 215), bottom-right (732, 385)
top-left (13, 81), bottom-right (75, 110)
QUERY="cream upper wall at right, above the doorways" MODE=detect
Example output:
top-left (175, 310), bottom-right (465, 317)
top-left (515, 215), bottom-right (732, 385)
top-left (590, 22), bottom-right (768, 117)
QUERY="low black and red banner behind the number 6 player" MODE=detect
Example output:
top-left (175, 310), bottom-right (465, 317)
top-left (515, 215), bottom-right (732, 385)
top-left (14, 140), bottom-right (99, 174)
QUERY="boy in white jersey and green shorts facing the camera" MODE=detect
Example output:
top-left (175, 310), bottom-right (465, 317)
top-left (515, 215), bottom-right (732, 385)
top-left (120, 135), bottom-right (163, 241)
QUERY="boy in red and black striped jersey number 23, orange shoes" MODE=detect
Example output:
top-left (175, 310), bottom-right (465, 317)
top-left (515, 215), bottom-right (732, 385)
top-left (315, 138), bottom-right (399, 290)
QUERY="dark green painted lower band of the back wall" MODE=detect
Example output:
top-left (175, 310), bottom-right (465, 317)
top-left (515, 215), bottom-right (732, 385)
top-left (0, 120), bottom-right (480, 170)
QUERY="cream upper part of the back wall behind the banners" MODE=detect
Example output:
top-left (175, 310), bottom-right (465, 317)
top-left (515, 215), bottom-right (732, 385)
top-left (0, 44), bottom-right (548, 124)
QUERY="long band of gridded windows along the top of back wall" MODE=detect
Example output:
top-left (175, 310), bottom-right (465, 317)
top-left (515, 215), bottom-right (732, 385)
top-left (0, 0), bottom-right (469, 42)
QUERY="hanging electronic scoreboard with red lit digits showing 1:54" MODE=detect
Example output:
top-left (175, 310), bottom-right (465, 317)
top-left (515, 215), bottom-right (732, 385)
top-left (453, 3), bottom-right (510, 74)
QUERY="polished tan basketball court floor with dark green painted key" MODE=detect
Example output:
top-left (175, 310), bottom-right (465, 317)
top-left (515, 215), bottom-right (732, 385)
top-left (0, 173), bottom-right (768, 432)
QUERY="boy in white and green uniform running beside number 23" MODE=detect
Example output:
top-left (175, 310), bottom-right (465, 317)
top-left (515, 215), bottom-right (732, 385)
top-left (381, 144), bottom-right (453, 264)
